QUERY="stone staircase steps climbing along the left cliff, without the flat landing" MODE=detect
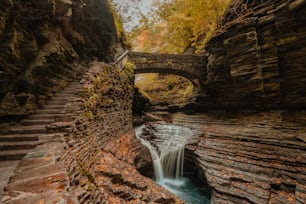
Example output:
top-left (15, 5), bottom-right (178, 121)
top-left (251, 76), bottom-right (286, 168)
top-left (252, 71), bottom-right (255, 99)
top-left (0, 81), bottom-right (80, 200)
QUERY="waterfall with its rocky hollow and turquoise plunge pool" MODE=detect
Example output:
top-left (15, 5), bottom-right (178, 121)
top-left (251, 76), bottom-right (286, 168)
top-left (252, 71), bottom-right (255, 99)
top-left (134, 122), bottom-right (211, 204)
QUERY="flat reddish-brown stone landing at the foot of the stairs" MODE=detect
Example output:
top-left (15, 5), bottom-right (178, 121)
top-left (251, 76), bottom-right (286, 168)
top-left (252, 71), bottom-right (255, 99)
top-left (1, 141), bottom-right (77, 203)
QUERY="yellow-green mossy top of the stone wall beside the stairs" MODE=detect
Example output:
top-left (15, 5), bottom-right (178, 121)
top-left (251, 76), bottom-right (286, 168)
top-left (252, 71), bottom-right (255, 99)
top-left (83, 62), bottom-right (134, 121)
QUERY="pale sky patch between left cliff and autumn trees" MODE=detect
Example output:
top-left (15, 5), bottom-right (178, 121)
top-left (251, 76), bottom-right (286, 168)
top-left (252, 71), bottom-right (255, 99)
top-left (112, 0), bottom-right (157, 31)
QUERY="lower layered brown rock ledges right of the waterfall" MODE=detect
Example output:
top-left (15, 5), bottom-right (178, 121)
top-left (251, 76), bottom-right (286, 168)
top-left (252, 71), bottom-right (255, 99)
top-left (174, 111), bottom-right (306, 204)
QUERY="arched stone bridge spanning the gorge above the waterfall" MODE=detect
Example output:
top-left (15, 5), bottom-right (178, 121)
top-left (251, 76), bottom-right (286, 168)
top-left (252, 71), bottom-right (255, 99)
top-left (128, 52), bottom-right (207, 90)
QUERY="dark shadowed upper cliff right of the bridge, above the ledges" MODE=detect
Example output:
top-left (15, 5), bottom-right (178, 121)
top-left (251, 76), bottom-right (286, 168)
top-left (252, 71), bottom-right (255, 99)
top-left (205, 0), bottom-right (306, 108)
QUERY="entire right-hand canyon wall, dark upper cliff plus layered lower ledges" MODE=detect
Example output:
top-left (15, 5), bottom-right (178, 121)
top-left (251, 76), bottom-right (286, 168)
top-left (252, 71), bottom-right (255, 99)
top-left (186, 0), bottom-right (306, 204)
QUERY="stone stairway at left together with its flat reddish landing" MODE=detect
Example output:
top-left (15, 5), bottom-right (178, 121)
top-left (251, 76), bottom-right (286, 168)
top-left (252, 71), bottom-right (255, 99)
top-left (0, 82), bottom-right (80, 203)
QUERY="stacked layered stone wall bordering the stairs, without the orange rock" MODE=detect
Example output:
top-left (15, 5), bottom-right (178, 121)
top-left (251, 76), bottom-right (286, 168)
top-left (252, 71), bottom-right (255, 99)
top-left (64, 63), bottom-right (133, 203)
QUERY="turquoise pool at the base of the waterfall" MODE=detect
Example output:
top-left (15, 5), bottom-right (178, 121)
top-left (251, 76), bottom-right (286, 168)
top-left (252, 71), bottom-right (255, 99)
top-left (158, 177), bottom-right (210, 204)
